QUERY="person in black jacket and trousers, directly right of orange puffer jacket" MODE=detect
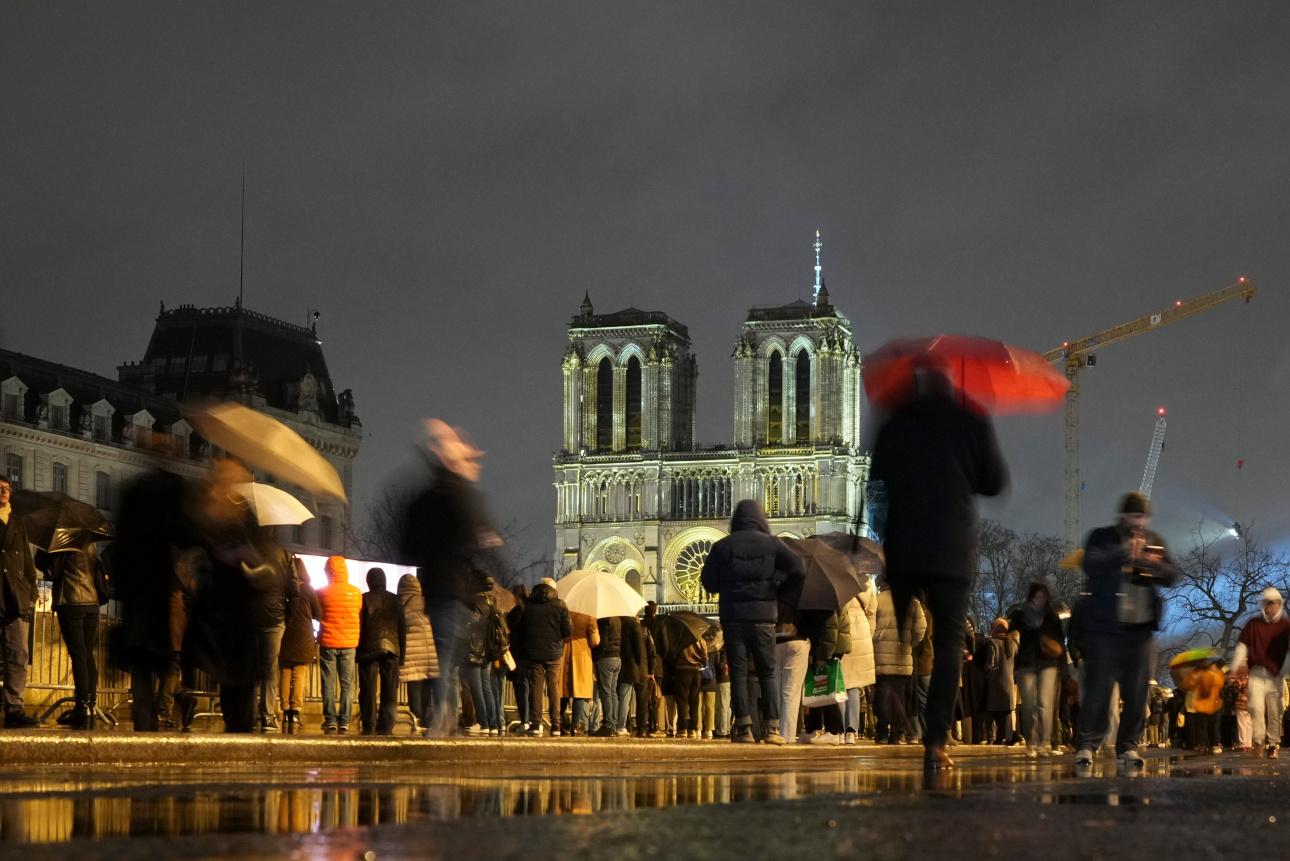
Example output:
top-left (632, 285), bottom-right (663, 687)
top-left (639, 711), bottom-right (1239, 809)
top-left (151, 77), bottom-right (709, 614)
top-left (355, 568), bottom-right (408, 736)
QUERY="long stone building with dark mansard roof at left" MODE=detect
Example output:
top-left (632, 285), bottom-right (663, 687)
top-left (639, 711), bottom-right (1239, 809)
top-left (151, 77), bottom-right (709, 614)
top-left (0, 303), bottom-right (362, 552)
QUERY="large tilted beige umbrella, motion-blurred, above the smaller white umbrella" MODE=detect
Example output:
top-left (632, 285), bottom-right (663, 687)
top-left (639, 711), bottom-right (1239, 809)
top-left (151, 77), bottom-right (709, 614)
top-left (184, 403), bottom-right (346, 500)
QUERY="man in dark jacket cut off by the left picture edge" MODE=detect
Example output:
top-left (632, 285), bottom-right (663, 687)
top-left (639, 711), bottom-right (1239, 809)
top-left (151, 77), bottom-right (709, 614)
top-left (0, 475), bottom-right (40, 728)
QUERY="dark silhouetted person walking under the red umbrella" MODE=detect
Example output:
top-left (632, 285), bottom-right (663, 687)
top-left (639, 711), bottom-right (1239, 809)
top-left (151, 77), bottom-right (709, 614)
top-left (869, 369), bottom-right (1007, 768)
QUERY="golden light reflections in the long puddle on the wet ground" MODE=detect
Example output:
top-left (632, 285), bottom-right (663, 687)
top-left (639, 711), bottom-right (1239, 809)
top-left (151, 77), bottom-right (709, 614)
top-left (0, 755), bottom-right (1241, 843)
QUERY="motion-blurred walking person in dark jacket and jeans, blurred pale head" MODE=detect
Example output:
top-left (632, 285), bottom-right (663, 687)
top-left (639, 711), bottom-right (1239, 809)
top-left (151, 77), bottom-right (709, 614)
top-left (400, 418), bottom-right (502, 736)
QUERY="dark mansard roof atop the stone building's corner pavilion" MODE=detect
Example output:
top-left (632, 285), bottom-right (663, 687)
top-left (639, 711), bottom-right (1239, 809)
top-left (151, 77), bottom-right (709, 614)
top-left (119, 303), bottom-right (343, 423)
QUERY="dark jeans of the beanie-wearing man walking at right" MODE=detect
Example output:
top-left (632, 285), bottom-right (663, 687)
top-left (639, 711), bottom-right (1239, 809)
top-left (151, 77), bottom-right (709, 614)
top-left (1076, 630), bottom-right (1152, 754)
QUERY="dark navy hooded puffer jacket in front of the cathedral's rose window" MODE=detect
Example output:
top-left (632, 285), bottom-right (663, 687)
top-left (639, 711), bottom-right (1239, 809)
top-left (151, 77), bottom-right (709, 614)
top-left (700, 500), bottom-right (804, 623)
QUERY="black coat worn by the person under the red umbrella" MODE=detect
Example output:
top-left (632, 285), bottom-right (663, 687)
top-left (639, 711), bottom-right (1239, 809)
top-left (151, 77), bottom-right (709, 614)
top-left (869, 392), bottom-right (1007, 582)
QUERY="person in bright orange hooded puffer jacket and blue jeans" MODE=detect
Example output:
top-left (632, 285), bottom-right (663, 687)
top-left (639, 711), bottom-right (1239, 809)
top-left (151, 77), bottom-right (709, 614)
top-left (319, 556), bottom-right (362, 736)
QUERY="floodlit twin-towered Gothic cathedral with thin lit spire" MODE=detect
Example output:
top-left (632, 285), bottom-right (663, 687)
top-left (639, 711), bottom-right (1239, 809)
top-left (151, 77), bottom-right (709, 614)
top-left (553, 232), bottom-right (869, 611)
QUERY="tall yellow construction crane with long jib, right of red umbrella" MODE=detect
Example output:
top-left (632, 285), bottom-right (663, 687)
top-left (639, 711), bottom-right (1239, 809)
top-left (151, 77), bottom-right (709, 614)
top-left (1044, 275), bottom-right (1254, 547)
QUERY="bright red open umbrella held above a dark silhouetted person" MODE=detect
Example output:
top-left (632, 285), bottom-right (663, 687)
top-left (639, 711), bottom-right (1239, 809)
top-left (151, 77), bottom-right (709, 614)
top-left (864, 334), bottom-right (1071, 413)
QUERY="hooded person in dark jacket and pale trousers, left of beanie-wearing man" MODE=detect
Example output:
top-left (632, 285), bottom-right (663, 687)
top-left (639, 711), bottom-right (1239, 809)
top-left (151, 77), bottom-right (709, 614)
top-left (1007, 582), bottom-right (1066, 759)
